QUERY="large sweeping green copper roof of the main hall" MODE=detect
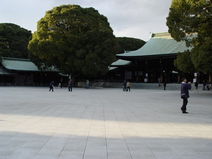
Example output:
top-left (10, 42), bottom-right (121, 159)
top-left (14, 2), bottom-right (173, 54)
top-left (117, 33), bottom-right (191, 58)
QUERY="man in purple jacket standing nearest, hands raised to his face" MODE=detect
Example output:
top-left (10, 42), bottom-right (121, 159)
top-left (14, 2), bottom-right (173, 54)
top-left (181, 78), bottom-right (191, 114)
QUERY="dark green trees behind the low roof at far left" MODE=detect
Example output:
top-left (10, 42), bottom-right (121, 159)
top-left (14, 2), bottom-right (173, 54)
top-left (0, 23), bottom-right (32, 58)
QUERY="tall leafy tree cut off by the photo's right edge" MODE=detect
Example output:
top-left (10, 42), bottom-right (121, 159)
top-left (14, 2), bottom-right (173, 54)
top-left (167, 0), bottom-right (212, 73)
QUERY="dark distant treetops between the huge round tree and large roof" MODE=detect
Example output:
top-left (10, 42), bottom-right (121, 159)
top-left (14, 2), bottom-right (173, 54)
top-left (116, 37), bottom-right (146, 53)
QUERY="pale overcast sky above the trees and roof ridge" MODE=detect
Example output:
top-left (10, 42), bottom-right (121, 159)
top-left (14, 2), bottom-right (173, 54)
top-left (0, 0), bottom-right (172, 41)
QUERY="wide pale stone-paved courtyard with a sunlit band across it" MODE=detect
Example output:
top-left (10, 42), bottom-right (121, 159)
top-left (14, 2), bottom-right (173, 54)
top-left (0, 87), bottom-right (212, 159)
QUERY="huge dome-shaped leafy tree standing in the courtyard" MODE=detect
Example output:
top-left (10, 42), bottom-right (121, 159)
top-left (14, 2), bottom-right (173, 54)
top-left (28, 5), bottom-right (118, 76)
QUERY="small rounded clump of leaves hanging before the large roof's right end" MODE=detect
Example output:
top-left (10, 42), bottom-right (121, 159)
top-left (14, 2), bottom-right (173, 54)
top-left (174, 50), bottom-right (195, 73)
